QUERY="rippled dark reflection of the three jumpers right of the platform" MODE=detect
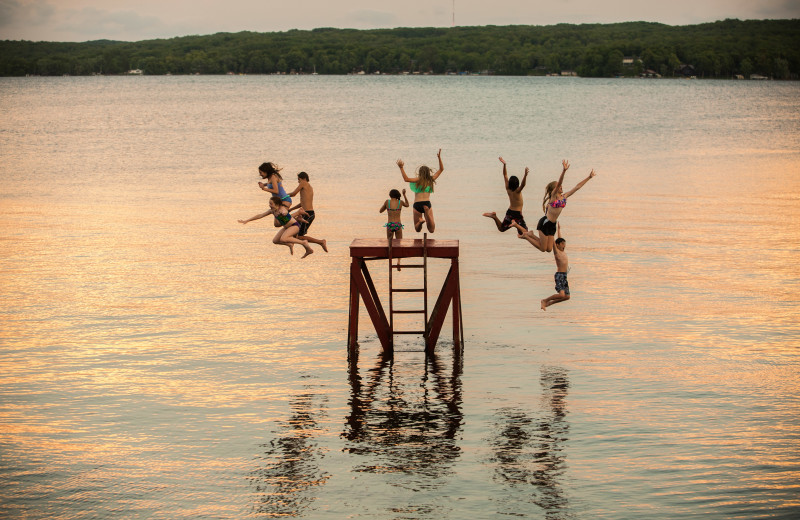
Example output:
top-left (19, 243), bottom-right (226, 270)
top-left (489, 367), bottom-right (571, 519)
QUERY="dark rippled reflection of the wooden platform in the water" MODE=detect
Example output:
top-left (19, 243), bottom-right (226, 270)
top-left (342, 354), bottom-right (463, 489)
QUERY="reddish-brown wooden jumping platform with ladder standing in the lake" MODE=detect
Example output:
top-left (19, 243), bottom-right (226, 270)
top-left (347, 237), bottom-right (463, 354)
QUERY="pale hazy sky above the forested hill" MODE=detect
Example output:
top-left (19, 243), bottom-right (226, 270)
top-left (0, 0), bottom-right (800, 42)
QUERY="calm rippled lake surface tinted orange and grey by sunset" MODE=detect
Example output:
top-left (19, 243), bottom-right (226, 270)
top-left (0, 76), bottom-right (800, 519)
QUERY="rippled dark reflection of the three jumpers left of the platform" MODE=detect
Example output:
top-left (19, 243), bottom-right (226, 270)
top-left (251, 393), bottom-right (330, 517)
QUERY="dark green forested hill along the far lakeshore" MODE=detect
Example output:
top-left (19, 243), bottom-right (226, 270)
top-left (0, 19), bottom-right (800, 79)
